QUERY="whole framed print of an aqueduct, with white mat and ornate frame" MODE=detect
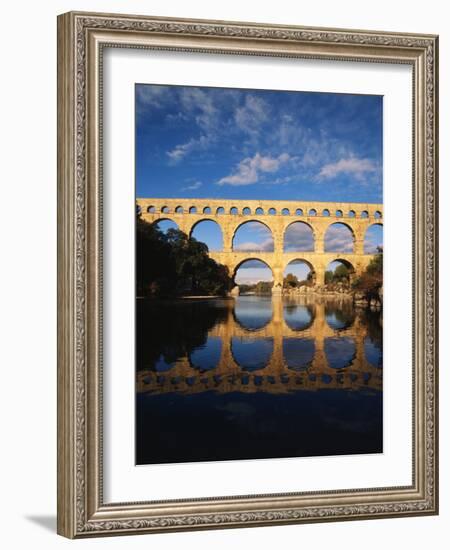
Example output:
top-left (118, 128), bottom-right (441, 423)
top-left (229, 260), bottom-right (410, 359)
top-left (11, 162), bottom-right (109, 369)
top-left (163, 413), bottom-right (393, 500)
top-left (58, 12), bottom-right (438, 538)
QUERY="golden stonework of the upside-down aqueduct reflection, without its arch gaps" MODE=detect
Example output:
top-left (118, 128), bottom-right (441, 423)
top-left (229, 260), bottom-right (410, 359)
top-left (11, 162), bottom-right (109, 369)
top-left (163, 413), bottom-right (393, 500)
top-left (136, 297), bottom-right (383, 394)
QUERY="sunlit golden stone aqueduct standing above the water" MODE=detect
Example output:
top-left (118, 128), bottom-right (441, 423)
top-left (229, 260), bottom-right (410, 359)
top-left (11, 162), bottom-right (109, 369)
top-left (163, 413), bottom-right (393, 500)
top-left (137, 198), bottom-right (383, 289)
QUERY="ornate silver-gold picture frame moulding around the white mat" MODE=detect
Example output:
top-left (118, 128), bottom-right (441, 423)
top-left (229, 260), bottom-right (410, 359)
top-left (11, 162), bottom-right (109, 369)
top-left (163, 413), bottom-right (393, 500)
top-left (58, 12), bottom-right (438, 538)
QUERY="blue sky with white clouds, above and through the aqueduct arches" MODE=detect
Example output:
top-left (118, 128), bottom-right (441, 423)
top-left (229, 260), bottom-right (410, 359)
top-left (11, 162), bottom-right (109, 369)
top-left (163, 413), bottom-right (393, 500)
top-left (140, 84), bottom-right (383, 281)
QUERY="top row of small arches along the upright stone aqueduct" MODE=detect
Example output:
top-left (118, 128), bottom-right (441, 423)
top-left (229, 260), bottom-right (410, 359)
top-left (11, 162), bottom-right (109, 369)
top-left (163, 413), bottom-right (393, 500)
top-left (141, 205), bottom-right (383, 219)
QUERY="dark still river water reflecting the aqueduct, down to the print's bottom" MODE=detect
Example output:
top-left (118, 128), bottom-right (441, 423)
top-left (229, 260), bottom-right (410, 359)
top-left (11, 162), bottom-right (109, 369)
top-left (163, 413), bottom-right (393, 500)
top-left (136, 296), bottom-right (383, 464)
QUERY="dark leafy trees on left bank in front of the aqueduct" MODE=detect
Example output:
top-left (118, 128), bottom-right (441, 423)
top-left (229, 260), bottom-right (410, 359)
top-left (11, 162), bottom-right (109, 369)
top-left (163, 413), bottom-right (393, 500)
top-left (136, 217), bottom-right (232, 296)
